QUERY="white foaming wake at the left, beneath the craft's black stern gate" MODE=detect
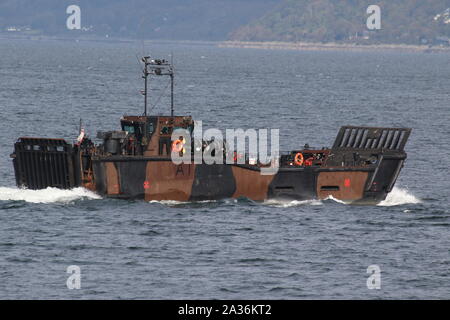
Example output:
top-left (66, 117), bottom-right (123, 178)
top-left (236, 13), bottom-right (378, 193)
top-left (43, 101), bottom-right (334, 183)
top-left (0, 187), bottom-right (101, 203)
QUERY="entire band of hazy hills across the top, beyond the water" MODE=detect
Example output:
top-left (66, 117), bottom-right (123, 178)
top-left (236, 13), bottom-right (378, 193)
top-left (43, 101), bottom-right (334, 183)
top-left (0, 0), bottom-right (450, 44)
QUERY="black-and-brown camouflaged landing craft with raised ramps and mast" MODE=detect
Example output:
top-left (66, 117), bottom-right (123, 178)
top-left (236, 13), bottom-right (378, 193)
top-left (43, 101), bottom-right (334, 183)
top-left (11, 57), bottom-right (411, 204)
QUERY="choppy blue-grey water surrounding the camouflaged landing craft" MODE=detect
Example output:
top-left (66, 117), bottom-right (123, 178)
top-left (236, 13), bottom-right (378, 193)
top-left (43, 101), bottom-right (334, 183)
top-left (0, 40), bottom-right (450, 299)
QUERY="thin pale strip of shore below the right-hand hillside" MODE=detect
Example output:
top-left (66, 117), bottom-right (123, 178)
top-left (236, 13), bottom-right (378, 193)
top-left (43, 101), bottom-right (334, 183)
top-left (218, 41), bottom-right (450, 52)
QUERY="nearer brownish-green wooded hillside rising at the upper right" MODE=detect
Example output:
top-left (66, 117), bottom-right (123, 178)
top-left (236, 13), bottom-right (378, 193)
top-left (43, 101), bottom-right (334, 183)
top-left (230, 0), bottom-right (450, 44)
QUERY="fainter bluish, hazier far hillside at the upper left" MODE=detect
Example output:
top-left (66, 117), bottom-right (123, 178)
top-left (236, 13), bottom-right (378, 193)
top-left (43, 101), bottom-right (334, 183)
top-left (0, 0), bottom-right (279, 40)
